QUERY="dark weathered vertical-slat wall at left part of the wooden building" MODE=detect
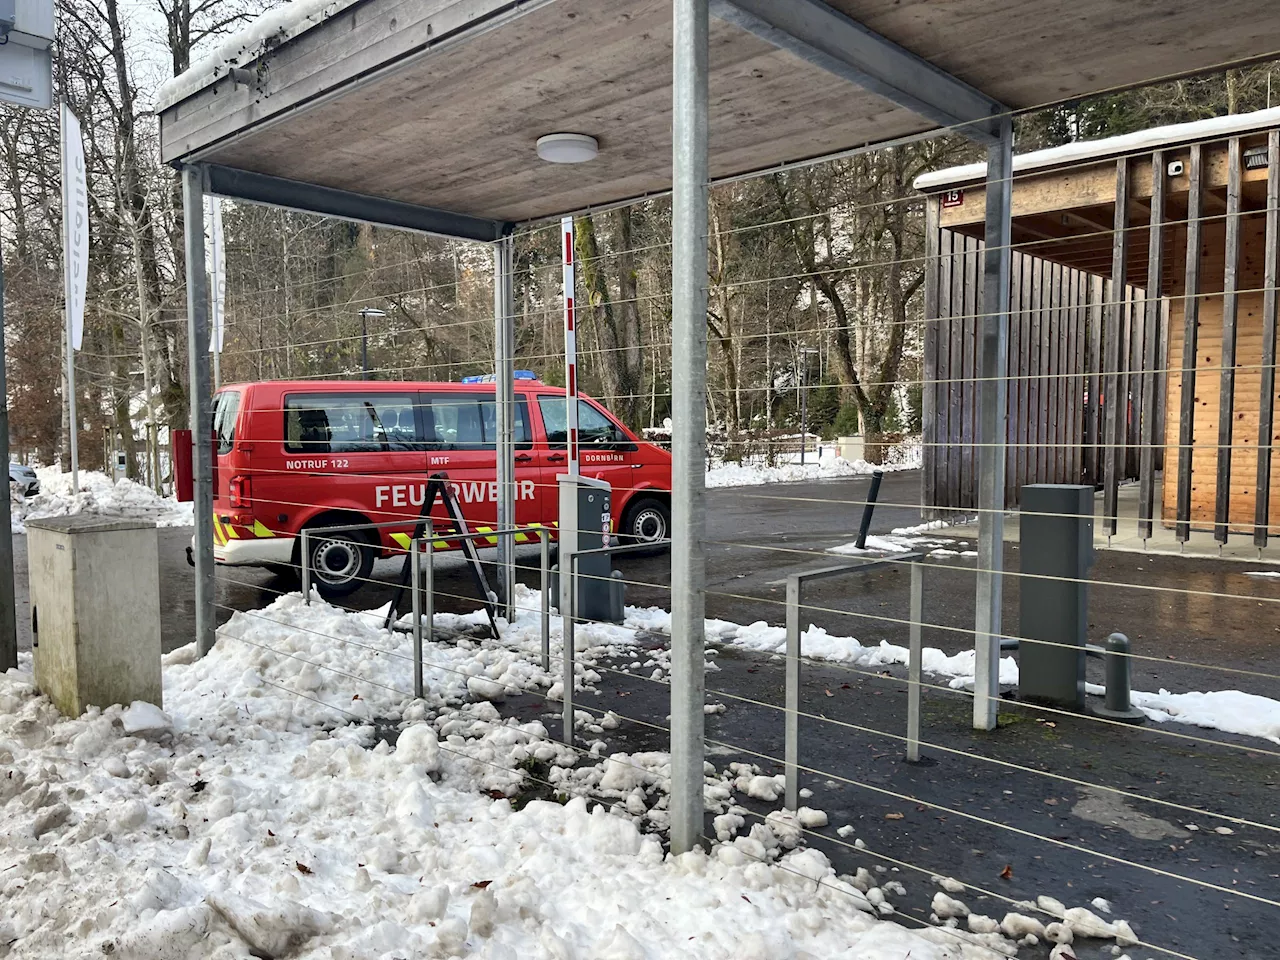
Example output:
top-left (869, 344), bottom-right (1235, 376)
top-left (923, 227), bottom-right (1165, 517)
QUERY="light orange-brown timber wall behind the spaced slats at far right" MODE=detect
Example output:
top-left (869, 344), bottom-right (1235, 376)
top-left (1162, 212), bottom-right (1280, 532)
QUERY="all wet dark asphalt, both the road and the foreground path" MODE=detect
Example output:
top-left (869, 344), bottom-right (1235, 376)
top-left (15, 472), bottom-right (1280, 960)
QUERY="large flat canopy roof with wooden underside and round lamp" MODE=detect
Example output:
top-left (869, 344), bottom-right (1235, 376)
top-left (160, 0), bottom-right (1280, 239)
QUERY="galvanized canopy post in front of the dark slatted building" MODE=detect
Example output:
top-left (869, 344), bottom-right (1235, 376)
top-left (952, 115), bottom-right (1014, 730)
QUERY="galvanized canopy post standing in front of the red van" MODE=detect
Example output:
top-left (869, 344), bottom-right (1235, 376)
top-left (493, 237), bottom-right (516, 622)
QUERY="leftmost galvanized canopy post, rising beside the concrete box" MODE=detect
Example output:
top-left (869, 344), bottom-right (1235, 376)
top-left (182, 166), bottom-right (218, 657)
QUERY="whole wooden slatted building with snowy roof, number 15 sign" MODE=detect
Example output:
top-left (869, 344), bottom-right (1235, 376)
top-left (915, 109), bottom-right (1280, 547)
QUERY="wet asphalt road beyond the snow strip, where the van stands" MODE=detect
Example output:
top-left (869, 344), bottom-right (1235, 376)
top-left (14, 471), bottom-right (1280, 696)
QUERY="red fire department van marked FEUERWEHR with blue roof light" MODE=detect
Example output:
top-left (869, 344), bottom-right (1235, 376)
top-left (199, 379), bottom-right (671, 596)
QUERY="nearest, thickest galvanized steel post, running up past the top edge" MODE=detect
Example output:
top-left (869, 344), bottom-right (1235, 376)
top-left (671, 0), bottom-right (708, 854)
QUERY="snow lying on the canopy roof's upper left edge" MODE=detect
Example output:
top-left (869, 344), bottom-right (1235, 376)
top-left (154, 0), bottom-right (361, 113)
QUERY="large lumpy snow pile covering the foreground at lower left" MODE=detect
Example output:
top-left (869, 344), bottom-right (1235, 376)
top-left (0, 596), bottom-right (966, 960)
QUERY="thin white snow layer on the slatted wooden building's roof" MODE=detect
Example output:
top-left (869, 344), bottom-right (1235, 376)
top-left (911, 106), bottom-right (1280, 193)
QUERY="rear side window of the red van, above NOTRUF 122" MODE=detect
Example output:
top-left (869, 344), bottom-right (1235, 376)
top-left (284, 393), bottom-right (422, 453)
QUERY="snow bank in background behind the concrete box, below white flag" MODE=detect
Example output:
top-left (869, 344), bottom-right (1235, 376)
top-left (10, 467), bottom-right (196, 534)
